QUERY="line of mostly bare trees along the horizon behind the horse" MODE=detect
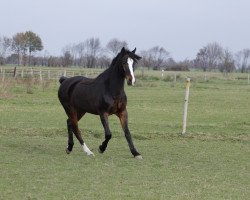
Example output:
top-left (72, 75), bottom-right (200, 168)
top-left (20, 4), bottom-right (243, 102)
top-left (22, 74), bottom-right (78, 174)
top-left (0, 31), bottom-right (250, 73)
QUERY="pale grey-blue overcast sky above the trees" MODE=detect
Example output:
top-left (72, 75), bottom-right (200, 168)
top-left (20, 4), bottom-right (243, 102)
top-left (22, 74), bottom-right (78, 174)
top-left (0, 0), bottom-right (250, 61)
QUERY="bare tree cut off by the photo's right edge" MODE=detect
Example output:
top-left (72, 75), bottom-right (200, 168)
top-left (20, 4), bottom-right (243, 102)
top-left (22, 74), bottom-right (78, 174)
top-left (235, 49), bottom-right (250, 73)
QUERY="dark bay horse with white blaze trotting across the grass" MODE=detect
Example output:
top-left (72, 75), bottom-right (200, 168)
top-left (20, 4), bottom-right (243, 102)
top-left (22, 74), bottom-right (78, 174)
top-left (58, 48), bottom-right (142, 158)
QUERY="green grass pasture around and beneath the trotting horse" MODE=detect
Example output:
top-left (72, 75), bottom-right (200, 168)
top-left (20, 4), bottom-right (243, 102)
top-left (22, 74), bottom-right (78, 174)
top-left (0, 69), bottom-right (250, 200)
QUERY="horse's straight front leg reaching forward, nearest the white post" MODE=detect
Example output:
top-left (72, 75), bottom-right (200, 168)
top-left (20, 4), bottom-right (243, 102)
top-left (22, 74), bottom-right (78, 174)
top-left (117, 109), bottom-right (142, 159)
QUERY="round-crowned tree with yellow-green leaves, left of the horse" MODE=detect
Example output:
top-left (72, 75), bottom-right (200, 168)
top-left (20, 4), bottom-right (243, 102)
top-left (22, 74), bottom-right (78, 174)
top-left (24, 31), bottom-right (43, 65)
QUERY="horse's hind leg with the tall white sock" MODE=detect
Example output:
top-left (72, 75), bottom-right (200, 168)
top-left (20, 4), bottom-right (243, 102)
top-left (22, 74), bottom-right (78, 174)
top-left (71, 113), bottom-right (94, 156)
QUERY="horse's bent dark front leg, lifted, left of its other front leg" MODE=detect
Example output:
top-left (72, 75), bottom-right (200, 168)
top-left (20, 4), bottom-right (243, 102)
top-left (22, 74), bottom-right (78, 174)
top-left (99, 113), bottom-right (112, 153)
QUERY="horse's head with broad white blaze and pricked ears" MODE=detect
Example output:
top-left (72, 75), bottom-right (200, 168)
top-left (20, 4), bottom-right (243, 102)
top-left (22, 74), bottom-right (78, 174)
top-left (120, 47), bottom-right (141, 85)
